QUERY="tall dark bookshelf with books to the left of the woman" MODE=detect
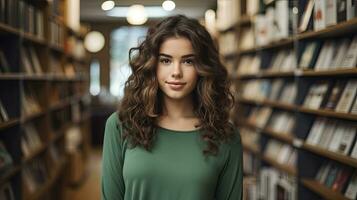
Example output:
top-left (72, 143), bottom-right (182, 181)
top-left (0, 0), bottom-right (90, 200)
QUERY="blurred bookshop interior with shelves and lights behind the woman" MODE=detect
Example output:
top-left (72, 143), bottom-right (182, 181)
top-left (0, 0), bottom-right (357, 200)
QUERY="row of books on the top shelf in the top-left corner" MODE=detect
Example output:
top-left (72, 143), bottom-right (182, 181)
top-left (0, 0), bottom-right (45, 39)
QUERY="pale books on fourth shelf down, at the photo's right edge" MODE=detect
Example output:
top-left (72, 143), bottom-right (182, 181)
top-left (306, 117), bottom-right (357, 159)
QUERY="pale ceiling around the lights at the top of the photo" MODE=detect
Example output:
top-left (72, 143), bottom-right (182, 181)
top-left (81, 0), bottom-right (217, 22)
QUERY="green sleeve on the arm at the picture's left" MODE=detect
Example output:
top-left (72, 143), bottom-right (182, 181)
top-left (101, 113), bottom-right (125, 200)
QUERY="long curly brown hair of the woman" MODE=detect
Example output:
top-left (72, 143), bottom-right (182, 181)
top-left (118, 15), bottom-right (234, 155)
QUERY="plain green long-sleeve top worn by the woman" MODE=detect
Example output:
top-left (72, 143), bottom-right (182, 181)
top-left (101, 113), bottom-right (243, 200)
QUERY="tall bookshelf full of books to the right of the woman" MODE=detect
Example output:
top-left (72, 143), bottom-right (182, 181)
top-left (218, 0), bottom-right (357, 199)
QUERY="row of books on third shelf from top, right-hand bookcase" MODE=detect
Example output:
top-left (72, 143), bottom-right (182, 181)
top-left (240, 79), bottom-right (357, 114)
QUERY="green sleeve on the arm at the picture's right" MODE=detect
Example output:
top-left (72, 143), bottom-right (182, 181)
top-left (216, 131), bottom-right (243, 200)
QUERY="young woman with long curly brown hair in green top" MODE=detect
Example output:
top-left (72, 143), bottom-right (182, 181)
top-left (101, 15), bottom-right (243, 200)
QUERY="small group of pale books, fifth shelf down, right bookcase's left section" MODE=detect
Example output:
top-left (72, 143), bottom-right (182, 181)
top-left (264, 139), bottom-right (297, 168)
